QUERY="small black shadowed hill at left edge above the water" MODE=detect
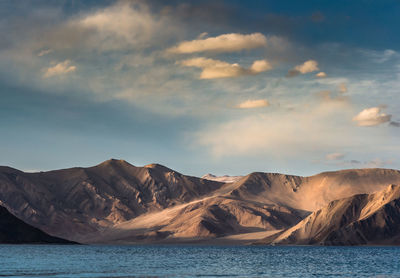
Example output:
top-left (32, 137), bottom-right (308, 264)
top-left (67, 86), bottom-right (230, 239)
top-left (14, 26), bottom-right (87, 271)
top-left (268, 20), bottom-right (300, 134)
top-left (0, 206), bottom-right (74, 244)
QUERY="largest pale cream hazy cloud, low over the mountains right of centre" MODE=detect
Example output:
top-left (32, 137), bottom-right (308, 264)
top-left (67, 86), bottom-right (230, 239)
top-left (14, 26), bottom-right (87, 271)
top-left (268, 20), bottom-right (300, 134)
top-left (194, 102), bottom-right (358, 158)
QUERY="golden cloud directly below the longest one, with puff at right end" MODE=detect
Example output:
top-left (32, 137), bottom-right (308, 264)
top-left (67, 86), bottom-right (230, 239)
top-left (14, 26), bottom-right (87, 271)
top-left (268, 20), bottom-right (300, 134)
top-left (180, 57), bottom-right (272, 79)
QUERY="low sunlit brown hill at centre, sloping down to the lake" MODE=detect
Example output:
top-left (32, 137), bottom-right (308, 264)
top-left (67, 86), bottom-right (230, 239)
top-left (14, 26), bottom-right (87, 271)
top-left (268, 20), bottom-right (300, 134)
top-left (83, 197), bottom-right (308, 243)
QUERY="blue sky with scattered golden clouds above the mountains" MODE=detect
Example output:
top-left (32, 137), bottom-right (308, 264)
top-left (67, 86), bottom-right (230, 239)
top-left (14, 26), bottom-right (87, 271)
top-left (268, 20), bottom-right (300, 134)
top-left (0, 0), bottom-right (400, 176)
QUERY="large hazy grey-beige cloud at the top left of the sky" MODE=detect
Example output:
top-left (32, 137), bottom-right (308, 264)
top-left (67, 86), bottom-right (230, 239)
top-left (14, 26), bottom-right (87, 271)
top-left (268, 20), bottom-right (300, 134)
top-left (66, 1), bottom-right (180, 51)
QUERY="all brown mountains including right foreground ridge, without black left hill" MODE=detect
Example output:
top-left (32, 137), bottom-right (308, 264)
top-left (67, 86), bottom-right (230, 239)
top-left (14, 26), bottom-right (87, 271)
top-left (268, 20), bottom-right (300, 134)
top-left (0, 159), bottom-right (400, 245)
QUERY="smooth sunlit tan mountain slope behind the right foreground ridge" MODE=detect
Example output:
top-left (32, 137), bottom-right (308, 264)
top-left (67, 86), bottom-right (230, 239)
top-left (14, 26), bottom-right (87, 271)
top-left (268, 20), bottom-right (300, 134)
top-left (227, 169), bottom-right (400, 211)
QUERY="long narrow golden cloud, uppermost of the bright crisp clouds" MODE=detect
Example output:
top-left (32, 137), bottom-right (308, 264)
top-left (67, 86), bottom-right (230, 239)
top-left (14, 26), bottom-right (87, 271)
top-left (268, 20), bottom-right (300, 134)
top-left (168, 33), bottom-right (267, 54)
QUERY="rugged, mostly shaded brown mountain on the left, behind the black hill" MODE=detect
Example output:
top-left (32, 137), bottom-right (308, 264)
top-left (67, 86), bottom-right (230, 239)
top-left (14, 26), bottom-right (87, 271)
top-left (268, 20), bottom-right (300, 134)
top-left (0, 159), bottom-right (224, 241)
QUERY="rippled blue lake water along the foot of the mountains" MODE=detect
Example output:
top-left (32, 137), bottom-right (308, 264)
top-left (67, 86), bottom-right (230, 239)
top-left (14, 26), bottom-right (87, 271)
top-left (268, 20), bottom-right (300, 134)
top-left (0, 245), bottom-right (400, 277)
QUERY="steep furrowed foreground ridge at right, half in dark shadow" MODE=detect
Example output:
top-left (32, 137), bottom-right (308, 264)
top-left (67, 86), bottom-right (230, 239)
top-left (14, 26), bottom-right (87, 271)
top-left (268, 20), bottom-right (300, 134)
top-left (261, 185), bottom-right (400, 245)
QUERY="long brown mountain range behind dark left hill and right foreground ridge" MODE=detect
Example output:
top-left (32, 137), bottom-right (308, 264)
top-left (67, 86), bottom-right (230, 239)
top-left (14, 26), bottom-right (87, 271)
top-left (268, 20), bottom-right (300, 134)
top-left (0, 159), bottom-right (400, 243)
